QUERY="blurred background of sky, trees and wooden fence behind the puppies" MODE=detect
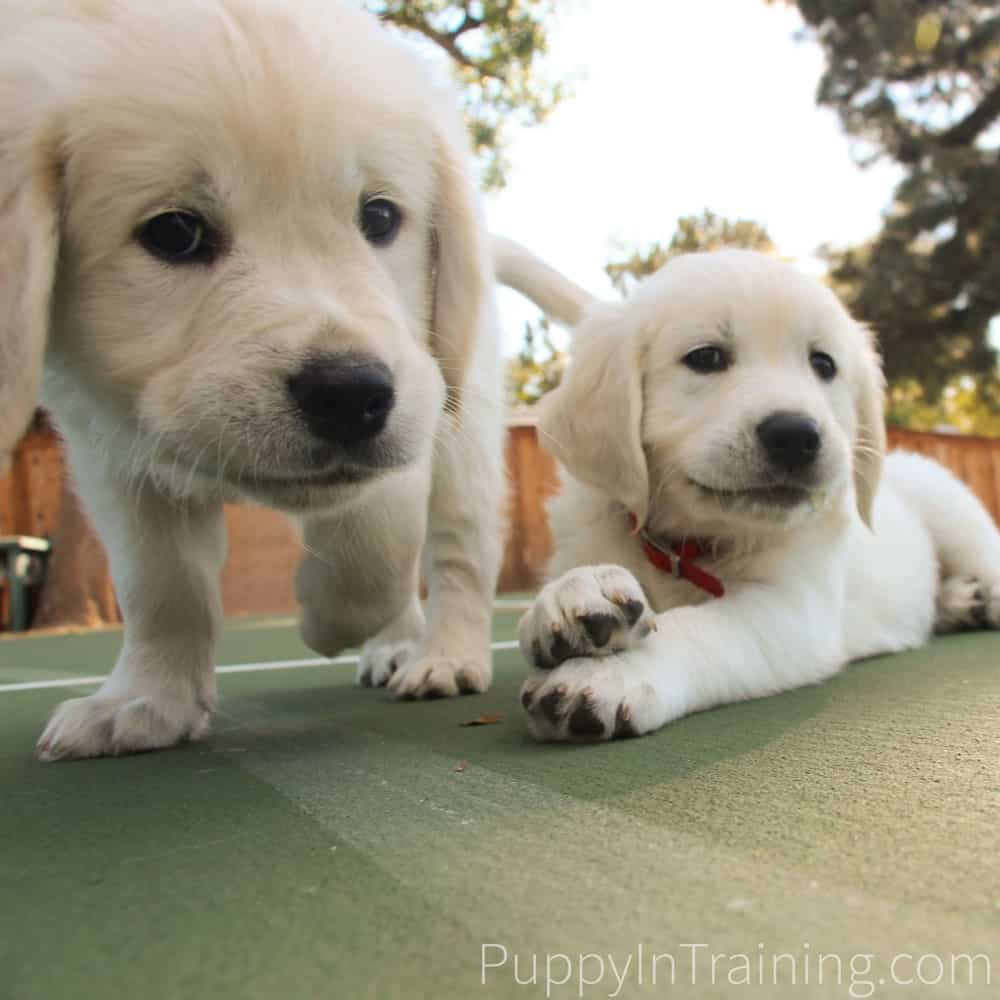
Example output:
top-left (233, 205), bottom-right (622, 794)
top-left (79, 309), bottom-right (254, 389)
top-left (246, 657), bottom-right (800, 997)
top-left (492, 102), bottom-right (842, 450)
top-left (0, 0), bottom-right (1000, 628)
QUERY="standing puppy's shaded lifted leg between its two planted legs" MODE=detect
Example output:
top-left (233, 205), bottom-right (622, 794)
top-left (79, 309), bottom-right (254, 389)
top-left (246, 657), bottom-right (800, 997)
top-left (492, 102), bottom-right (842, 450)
top-left (296, 465), bottom-right (430, 660)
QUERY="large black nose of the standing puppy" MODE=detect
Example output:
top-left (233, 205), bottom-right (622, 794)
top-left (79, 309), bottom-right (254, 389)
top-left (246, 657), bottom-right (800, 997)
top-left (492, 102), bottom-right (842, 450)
top-left (288, 354), bottom-right (396, 445)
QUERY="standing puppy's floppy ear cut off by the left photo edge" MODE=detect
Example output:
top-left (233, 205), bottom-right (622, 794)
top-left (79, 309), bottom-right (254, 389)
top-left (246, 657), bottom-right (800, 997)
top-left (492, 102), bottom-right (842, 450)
top-left (0, 136), bottom-right (59, 470)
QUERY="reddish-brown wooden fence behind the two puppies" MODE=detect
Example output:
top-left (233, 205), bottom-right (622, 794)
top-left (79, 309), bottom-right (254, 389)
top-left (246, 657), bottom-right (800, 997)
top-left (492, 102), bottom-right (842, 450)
top-left (0, 419), bottom-right (1000, 628)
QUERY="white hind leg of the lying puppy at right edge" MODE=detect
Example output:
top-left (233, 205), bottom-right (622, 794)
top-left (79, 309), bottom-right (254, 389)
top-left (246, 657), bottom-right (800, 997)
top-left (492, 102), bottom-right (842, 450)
top-left (887, 453), bottom-right (1000, 632)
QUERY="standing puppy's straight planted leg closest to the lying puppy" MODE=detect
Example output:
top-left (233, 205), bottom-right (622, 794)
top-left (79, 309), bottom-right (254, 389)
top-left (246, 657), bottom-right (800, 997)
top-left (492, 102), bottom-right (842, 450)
top-left (388, 396), bottom-right (504, 698)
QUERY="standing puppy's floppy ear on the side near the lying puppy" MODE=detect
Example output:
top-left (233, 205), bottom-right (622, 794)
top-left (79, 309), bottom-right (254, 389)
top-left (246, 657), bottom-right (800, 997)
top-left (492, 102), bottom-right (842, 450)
top-left (430, 129), bottom-right (484, 409)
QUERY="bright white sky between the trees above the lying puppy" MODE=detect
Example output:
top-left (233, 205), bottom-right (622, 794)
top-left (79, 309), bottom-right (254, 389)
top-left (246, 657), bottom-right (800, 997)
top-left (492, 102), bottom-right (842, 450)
top-left (486, 0), bottom-right (899, 354)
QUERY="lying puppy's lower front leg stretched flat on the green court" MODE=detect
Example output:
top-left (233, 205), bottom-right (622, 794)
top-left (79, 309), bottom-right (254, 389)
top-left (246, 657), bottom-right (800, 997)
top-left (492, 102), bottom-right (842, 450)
top-left (521, 570), bottom-right (845, 741)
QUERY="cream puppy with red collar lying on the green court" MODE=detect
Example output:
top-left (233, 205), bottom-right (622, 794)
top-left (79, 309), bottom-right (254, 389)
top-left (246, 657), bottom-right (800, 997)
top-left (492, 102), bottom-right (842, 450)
top-left (496, 242), bottom-right (1000, 740)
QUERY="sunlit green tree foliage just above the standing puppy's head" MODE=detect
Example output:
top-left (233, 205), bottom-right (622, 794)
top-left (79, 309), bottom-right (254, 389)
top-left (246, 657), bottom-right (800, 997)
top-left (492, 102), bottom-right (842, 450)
top-left (372, 0), bottom-right (564, 188)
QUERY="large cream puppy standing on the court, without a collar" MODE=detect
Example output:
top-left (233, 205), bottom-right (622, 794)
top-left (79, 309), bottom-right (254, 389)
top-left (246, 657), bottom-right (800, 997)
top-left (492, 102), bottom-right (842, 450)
top-left (0, 0), bottom-right (503, 759)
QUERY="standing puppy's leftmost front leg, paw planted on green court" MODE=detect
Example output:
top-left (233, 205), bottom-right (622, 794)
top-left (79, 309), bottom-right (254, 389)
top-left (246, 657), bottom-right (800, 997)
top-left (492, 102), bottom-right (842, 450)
top-left (38, 463), bottom-right (226, 760)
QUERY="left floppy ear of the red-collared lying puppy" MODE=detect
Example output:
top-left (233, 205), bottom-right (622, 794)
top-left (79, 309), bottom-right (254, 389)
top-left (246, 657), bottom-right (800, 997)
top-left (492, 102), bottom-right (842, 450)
top-left (538, 306), bottom-right (649, 525)
